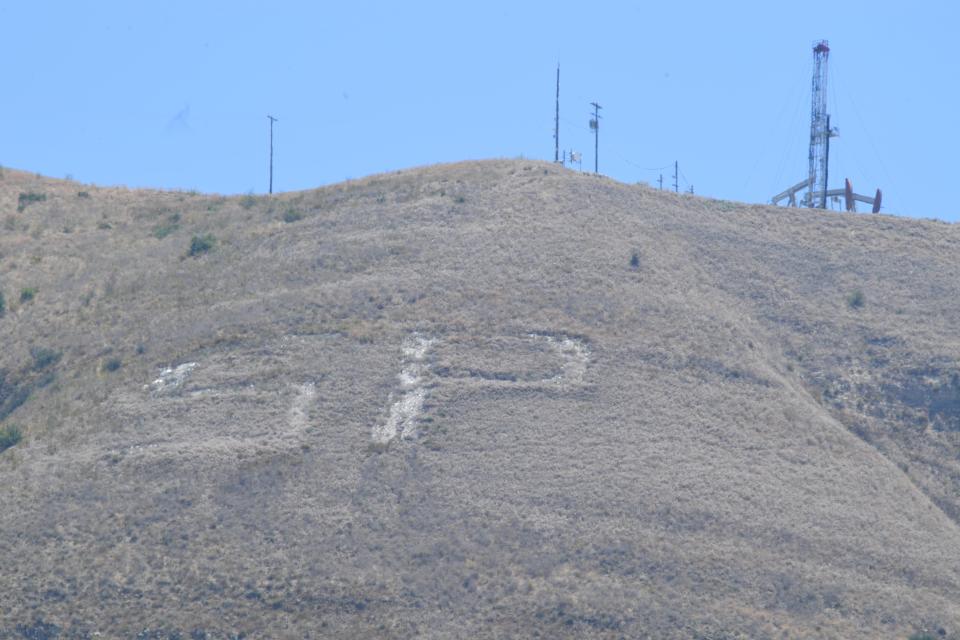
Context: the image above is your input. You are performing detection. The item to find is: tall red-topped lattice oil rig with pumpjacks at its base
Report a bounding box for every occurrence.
[772,40,883,213]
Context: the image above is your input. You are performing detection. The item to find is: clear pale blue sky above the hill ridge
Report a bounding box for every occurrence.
[0,0,960,220]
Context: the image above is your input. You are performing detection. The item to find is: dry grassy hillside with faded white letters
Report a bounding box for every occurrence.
[0,161,960,640]
